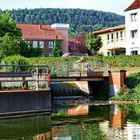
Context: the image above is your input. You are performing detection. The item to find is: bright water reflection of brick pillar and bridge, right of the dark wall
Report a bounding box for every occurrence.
[52,100,140,140]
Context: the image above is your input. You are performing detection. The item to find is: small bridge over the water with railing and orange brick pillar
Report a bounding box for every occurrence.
[50,63,126,96]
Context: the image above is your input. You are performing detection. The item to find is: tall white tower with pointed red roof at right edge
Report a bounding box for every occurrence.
[125,0,140,55]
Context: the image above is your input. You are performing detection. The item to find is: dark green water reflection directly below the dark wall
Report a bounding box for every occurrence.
[0,115,51,140]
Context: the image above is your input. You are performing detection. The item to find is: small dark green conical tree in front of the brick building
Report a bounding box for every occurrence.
[52,37,62,57]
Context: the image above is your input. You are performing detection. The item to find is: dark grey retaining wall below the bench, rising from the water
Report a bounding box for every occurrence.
[0,90,51,116]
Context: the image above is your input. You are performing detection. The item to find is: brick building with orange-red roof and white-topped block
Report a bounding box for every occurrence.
[16,23,69,56]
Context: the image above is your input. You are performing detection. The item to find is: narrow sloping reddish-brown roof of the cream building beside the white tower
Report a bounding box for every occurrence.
[94,25,125,35]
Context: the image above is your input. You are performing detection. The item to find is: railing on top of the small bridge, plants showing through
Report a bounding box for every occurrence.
[49,61,110,77]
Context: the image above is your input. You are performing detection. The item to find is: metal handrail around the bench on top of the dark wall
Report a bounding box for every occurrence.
[0,64,50,90]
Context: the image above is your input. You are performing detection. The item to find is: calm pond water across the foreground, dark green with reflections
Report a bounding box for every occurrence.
[0,99,140,140]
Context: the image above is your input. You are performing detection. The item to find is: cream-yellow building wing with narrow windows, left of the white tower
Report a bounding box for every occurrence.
[94,25,126,56]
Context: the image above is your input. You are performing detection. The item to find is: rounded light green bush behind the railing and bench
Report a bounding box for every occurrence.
[1,55,29,72]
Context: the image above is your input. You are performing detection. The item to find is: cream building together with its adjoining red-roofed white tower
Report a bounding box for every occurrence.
[94,0,140,55]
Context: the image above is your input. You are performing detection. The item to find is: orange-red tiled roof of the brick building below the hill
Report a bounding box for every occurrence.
[16,24,64,40]
